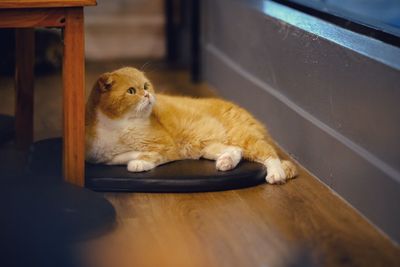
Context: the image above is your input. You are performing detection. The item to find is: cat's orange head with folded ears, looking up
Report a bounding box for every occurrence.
[92,67,156,119]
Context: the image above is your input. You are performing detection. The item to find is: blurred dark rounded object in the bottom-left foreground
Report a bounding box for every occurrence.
[0,176,116,266]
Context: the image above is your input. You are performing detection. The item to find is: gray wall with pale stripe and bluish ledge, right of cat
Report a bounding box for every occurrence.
[202,0,400,245]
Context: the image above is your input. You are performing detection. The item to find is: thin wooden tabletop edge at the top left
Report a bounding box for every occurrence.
[0,0,97,9]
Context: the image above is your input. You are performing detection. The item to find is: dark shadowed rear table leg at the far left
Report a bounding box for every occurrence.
[15,28,35,149]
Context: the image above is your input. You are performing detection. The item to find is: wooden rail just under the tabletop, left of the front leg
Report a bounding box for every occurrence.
[0,8,65,28]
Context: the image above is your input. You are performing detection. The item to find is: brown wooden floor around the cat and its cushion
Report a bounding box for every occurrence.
[0,63,400,267]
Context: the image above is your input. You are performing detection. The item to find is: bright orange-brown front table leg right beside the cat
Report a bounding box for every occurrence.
[63,7,85,186]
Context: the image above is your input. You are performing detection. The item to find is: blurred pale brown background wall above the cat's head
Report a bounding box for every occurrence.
[85,0,165,61]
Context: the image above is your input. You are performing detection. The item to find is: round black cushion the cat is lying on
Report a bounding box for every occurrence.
[29,139,266,192]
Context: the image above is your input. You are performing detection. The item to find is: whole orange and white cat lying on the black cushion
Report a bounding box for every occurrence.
[86,67,296,184]
